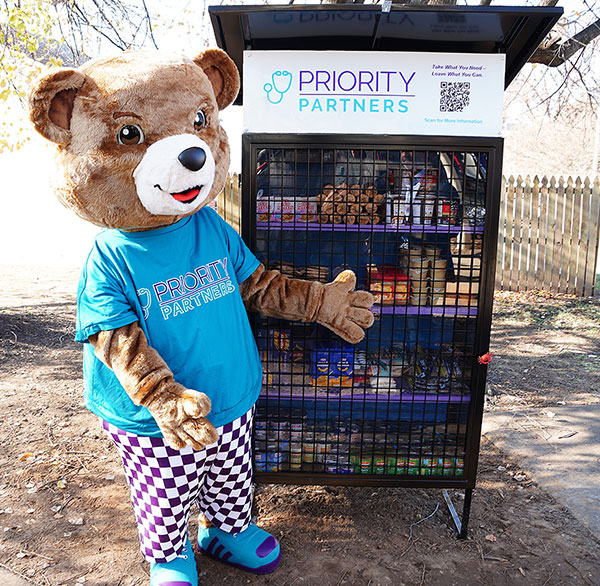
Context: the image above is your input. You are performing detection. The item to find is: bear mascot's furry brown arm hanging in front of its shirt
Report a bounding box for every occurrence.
[89,322,218,450]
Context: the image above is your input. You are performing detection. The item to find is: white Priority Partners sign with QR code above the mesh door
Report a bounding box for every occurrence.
[244,51,505,136]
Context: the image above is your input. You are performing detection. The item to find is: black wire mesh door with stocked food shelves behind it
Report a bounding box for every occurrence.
[245,137,496,486]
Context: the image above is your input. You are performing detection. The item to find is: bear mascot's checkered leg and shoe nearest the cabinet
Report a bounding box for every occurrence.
[198,409,281,574]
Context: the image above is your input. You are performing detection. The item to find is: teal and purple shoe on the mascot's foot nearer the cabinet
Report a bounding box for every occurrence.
[198,523,281,574]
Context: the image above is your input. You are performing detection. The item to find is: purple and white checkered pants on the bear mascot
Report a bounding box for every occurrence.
[103,409,253,563]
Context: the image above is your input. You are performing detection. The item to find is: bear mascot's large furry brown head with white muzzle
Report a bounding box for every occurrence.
[29,49,240,230]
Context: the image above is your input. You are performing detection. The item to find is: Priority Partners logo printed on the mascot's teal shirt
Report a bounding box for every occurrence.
[137,258,236,320]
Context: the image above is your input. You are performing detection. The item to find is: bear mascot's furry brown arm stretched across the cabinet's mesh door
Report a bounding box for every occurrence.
[240,264,374,344]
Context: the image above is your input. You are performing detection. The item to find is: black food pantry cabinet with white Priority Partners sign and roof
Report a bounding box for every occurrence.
[211,6,560,537]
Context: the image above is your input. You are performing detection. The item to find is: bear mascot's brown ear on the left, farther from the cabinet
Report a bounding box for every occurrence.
[29,68,85,145]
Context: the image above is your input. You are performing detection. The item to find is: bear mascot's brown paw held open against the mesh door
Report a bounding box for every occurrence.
[317,271,375,344]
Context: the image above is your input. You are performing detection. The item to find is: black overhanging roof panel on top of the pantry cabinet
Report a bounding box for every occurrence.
[209,4,563,104]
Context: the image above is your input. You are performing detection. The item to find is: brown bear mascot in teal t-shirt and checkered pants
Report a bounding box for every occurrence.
[29,49,373,586]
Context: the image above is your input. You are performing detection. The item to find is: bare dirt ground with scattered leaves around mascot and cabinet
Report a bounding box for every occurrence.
[0,267,600,586]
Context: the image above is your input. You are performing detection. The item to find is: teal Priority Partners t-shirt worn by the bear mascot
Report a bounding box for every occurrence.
[75,208,262,436]
